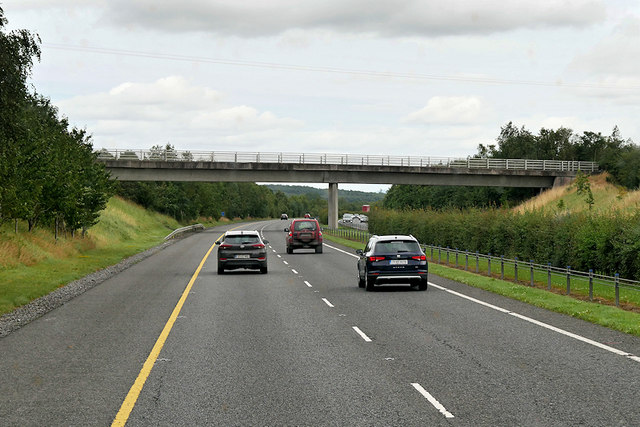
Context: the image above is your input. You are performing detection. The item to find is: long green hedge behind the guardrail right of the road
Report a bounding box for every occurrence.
[369,209,640,280]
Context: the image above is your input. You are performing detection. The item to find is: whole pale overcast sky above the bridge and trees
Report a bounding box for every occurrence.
[0,0,640,188]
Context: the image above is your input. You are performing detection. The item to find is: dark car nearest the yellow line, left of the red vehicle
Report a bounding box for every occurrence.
[218,230,269,274]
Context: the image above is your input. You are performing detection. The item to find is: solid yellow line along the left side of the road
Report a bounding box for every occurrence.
[111,232,229,427]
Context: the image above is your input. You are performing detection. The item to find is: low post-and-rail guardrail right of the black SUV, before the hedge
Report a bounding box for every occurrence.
[424,245,640,307]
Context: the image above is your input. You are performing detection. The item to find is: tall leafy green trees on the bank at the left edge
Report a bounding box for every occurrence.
[0,7,113,237]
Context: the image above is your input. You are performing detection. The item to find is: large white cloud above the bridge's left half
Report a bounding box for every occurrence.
[58,76,302,148]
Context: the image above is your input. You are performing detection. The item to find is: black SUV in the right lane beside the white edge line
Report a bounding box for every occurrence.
[356,235,429,291]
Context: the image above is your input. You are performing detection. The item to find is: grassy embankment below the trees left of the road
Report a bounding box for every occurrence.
[0,197,188,314]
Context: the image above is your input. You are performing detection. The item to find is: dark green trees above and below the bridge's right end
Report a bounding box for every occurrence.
[382,122,640,209]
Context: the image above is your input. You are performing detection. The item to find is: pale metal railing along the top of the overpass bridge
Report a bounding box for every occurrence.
[97,148,598,172]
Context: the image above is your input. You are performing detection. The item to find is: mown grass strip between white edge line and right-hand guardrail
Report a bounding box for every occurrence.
[324,234,640,336]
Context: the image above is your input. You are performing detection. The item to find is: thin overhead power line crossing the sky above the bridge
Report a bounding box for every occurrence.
[42,43,640,90]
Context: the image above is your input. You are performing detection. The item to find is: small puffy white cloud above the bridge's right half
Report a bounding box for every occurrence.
[404,96,488,124]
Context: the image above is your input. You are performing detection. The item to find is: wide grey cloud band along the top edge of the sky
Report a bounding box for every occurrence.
[101,0,605,37]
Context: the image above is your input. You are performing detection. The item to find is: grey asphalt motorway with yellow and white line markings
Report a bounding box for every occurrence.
[0,220,640,426]
